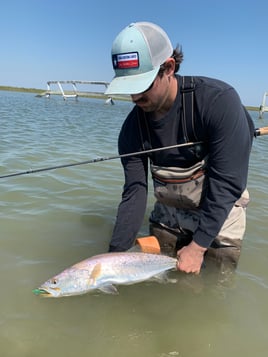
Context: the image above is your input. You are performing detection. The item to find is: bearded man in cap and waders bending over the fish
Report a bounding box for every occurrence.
[106,22,254,273]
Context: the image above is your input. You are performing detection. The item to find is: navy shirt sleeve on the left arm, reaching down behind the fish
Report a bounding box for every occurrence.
[109,111,148,251]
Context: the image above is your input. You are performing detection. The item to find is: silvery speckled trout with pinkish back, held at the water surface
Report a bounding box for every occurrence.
[33,252,177,297]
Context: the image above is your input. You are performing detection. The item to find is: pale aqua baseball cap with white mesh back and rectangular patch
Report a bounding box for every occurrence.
[105,22,173,94]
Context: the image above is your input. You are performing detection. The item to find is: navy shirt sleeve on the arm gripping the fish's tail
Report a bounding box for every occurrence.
[193,88,253,248]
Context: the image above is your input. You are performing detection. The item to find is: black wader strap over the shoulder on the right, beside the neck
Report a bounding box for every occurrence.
[180,76,198,142]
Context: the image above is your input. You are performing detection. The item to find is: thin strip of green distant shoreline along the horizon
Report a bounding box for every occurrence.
[0,86,260,111]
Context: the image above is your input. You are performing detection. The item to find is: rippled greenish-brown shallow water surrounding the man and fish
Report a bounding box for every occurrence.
[0,92,268,357]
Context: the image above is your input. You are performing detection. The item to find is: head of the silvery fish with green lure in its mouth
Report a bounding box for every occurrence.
[33,268,91,298]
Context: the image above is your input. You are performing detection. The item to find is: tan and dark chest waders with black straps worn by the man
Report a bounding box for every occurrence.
[139,76,249,266]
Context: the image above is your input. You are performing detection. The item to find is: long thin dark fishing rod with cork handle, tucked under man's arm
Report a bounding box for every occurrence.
[0,126,268,179]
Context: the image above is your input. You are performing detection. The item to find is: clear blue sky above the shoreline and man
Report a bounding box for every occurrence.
[0,0,268,106]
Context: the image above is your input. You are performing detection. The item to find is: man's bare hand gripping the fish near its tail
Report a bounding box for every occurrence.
[177,242,207,274]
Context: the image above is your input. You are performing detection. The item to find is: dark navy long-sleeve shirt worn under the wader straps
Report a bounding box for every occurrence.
[110,76,254,251]
